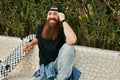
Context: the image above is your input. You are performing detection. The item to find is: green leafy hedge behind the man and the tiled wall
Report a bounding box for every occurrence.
[0,0,120,51]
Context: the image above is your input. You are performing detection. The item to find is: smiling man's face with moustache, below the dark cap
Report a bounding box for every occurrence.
[47,11,59,24]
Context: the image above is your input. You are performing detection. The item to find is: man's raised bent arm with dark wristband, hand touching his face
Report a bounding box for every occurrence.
[58,13,77,44]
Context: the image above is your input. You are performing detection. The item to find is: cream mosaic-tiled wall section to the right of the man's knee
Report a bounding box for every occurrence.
[75,46,120,80]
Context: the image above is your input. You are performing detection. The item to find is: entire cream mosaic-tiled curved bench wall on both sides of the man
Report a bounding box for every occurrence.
[0,36,120,80]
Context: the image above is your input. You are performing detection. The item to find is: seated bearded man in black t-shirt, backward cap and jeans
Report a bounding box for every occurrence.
[23,4,77,80]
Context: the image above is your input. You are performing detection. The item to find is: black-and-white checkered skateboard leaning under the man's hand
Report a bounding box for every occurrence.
[0,34,36,80]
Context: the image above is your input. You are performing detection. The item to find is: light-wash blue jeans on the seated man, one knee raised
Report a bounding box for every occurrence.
[30,43,76,80]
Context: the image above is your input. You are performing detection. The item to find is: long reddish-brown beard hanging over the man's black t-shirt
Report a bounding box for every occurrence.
[42,18,61,40]
